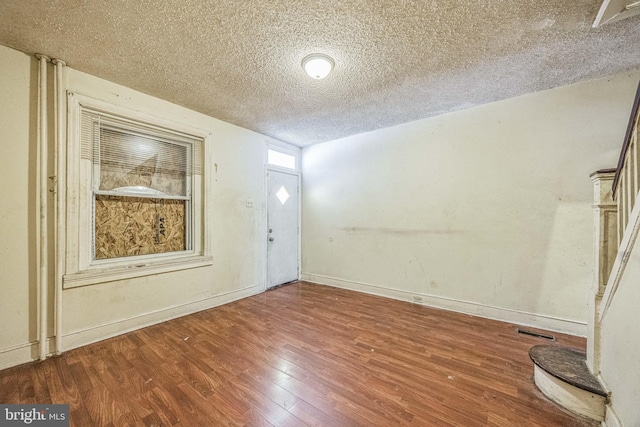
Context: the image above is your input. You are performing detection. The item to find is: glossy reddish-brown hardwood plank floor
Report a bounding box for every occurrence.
[0,282,597,427]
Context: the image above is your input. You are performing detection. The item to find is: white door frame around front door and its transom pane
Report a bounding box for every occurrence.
[262,143,302,292]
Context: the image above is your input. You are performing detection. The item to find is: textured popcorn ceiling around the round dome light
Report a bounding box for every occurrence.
[0,0,640,146]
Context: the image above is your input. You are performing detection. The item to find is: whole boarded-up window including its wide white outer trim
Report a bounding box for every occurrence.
[64,94,211,287]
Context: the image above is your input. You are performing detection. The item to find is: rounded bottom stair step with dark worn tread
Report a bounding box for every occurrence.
[529,345,608,421]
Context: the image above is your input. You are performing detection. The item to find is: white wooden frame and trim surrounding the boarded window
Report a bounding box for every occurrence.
[63,92,213,289]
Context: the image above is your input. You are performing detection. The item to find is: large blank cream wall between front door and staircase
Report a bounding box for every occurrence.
[302,72,640,335]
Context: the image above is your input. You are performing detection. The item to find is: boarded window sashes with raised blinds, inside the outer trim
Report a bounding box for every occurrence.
[82,110,201,260]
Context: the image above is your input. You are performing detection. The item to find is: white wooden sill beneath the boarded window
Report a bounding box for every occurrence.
[62,255,213,289]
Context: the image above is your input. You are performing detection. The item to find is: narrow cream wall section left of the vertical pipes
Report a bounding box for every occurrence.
[0,46,37,368]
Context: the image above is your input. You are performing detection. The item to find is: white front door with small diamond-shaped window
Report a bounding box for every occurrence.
[267,170,300,288]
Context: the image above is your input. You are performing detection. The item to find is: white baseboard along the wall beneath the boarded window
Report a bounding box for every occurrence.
[0,284,264,370]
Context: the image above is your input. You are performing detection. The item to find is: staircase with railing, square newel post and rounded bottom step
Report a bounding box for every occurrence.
[529,84,640,426]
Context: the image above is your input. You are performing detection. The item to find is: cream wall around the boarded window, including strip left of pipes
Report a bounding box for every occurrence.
[0,46,300,369]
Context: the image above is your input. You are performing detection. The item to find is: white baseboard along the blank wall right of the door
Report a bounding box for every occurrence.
[300,273,587,337]
